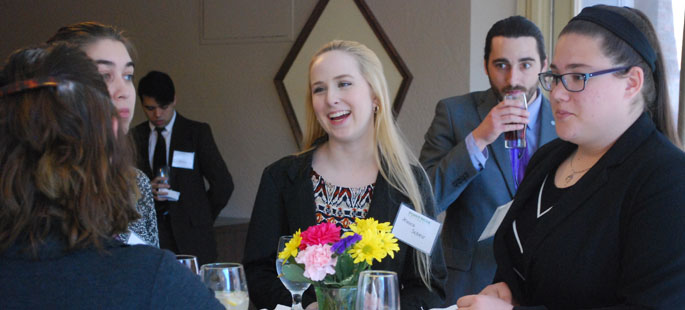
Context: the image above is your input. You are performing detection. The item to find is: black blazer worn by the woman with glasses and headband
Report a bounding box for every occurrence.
[494,114,685,309]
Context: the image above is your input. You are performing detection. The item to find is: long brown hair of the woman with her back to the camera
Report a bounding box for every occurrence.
[0,44,138,252]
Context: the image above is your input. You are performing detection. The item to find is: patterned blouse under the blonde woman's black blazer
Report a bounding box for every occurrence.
[312,170,376,231]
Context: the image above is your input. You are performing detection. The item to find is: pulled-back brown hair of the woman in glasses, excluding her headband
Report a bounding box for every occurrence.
[559,5,682,147]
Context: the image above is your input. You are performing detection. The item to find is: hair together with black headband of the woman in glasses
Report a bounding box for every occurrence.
[559,5,680,146]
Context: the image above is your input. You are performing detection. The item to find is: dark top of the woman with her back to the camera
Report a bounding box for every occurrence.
[0,237,224,310]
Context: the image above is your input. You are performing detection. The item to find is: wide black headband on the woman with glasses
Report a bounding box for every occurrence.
[571,6,656,72]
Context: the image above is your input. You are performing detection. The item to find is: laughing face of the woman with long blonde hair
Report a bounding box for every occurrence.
[309,51,376,147]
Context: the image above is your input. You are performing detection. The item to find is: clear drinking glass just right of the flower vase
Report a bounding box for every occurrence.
[356,270,400,310]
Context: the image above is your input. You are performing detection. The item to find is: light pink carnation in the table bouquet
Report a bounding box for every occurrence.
[295,244,338,281]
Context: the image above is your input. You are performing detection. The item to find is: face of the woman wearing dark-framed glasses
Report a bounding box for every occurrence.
[549,33,642,146]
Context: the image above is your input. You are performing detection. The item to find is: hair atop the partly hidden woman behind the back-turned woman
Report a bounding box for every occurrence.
[48,22,136,59]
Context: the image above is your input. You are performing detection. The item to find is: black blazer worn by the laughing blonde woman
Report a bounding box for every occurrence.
[243,151,447,309]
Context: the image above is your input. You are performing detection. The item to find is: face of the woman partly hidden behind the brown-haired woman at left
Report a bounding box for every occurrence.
[84,39,136,132]
